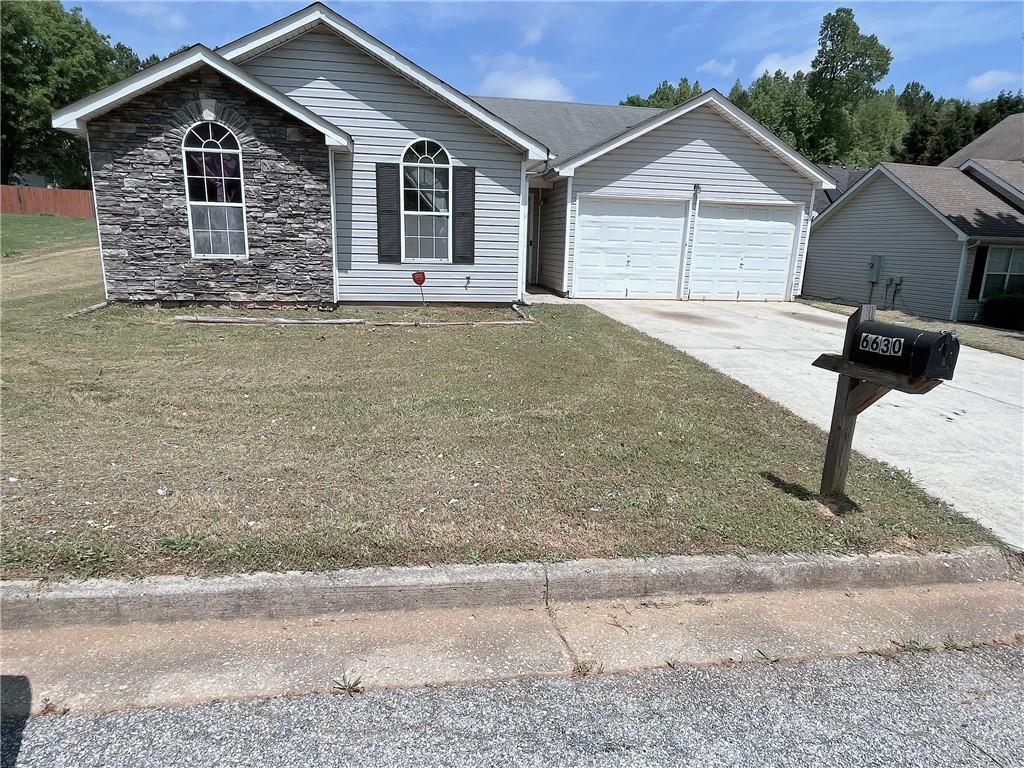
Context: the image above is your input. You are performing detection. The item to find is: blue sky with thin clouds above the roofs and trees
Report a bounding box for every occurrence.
[75,0,1024,103]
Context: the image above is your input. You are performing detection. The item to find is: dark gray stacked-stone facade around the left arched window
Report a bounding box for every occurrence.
[88,68,334,302]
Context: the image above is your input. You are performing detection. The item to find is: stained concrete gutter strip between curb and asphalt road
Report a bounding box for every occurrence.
[0,582,1024,713]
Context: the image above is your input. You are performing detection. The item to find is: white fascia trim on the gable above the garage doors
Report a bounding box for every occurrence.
[554,90,836,189]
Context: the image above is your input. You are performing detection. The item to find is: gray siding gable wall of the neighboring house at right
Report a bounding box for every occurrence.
[803,173,971,318]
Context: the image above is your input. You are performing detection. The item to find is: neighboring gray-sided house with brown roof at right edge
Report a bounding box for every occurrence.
[803,125,1024,321]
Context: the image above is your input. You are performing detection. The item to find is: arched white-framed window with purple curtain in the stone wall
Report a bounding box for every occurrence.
[183,123,247,259]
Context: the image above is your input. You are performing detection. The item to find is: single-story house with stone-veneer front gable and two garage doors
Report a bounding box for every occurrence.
[53,3,834,303]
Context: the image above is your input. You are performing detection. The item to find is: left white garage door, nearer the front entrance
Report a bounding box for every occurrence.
[573,198,686,299]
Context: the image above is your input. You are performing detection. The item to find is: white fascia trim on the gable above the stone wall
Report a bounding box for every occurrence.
[53,45,352,151]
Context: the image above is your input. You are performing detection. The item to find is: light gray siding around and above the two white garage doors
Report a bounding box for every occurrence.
[568,106,814,296]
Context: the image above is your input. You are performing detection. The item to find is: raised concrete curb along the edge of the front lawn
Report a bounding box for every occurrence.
[0,547,1018,630]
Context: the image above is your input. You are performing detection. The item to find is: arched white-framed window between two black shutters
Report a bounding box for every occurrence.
[401,138,452,262]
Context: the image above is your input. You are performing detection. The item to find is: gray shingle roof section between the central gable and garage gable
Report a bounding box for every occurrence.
[473,96,663,158]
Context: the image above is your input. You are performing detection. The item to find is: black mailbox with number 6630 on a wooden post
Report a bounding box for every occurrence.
[850,321,959,380]
